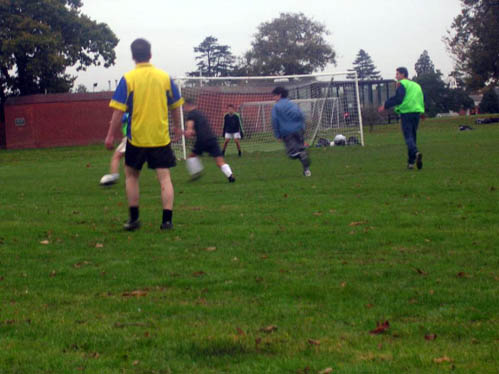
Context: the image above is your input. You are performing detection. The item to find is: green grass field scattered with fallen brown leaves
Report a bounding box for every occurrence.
[0,119,499,374]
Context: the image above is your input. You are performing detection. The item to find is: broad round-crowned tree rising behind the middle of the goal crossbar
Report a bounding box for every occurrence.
[239,13,336,75]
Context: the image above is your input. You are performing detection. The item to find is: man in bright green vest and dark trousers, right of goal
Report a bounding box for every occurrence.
[378,67,424,169]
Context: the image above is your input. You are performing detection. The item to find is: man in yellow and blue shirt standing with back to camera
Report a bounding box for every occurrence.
[105,39,183,231]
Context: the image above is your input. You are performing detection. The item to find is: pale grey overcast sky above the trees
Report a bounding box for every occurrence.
[72,0,461,90]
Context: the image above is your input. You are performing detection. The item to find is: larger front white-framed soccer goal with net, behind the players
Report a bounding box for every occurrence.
[174,72,364,158]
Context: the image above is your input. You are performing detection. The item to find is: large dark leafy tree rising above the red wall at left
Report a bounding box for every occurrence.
[0,0,118,118]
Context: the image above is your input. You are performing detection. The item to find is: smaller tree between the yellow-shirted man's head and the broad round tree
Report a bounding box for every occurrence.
[187,36,235,77]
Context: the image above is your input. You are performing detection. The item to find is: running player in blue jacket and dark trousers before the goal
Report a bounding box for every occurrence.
[272,87,312,177]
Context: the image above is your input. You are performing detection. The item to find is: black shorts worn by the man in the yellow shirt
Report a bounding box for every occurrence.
[125,141,177,170]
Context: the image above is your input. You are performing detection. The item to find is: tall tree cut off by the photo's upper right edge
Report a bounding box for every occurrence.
[444,0,499,89]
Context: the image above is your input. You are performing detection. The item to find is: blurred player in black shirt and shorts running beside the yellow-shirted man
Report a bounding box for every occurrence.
[184,98,236,183]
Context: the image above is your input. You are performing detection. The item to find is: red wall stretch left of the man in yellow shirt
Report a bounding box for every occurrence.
[5,92,112,149]
